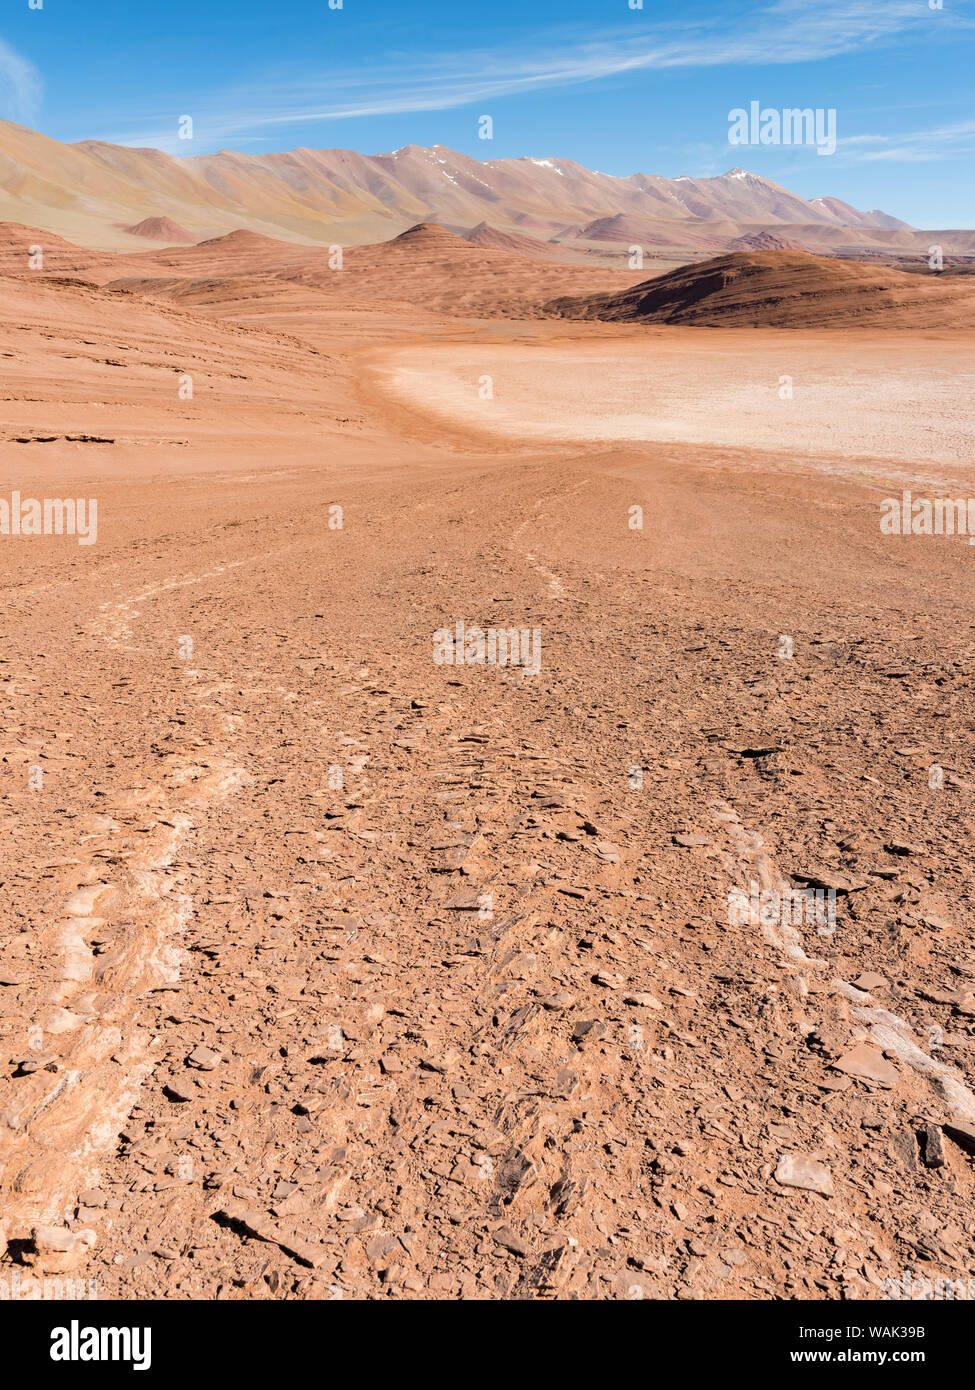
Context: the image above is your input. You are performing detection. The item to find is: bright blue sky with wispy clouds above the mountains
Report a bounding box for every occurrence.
[0,0,975,227]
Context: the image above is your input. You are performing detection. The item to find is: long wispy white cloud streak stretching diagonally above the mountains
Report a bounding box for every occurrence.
[102,0,945,154]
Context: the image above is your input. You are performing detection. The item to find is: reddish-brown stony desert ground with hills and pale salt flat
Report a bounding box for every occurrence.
[0,227,975,1300]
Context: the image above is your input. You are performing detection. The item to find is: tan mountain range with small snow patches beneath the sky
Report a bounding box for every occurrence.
[0,121,975,259]
